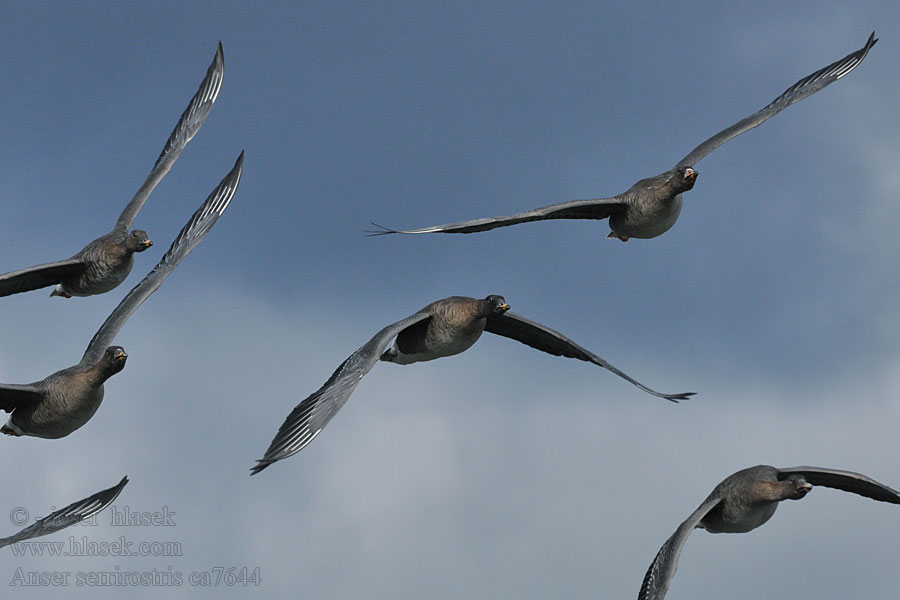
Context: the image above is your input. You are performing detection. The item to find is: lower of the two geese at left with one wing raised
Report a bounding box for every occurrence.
[0,152,244,438]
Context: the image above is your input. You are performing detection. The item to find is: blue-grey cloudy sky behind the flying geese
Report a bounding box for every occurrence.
[0,2,900,600]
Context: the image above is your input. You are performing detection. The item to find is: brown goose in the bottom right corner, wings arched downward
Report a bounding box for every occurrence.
[638,465,900,600]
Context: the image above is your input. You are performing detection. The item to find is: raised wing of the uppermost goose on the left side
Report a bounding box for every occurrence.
[115,42,225,231]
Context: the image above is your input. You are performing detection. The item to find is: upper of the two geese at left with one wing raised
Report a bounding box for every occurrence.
[0,42,225,298]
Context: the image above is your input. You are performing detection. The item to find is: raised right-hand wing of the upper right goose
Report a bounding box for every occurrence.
[675,31,878,169]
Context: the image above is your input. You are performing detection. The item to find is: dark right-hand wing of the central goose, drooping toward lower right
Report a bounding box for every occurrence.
[484,312,694,402]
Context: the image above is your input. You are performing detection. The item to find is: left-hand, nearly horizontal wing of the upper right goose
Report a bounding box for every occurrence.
[367,197,625,236]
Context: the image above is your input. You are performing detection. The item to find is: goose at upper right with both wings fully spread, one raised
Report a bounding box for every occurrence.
[368,32,878,242]
